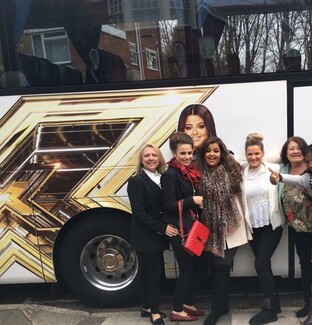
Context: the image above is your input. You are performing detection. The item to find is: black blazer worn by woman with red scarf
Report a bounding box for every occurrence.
[160,166,197,230]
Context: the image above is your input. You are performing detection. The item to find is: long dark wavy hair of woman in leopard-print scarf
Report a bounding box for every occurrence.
[196,137,243,194]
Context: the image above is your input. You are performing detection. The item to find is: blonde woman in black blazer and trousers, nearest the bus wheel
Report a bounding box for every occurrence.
[128,144,177,325]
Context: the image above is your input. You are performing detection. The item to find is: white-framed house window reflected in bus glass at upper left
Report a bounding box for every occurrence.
[32,28,71,64]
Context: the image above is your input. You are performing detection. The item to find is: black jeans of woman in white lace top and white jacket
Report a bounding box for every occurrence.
[249,225,283,298]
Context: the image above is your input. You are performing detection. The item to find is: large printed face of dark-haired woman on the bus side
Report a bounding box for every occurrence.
[183,115,209,148]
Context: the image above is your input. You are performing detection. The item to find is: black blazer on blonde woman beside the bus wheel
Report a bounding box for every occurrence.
[127,171,168,253]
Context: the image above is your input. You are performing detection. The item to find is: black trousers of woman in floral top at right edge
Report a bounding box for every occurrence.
[289,227,312,301]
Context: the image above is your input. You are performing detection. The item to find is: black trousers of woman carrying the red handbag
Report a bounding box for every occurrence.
[169,236,204,312]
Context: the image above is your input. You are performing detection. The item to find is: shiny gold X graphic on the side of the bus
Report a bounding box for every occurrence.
[0,87,216,304]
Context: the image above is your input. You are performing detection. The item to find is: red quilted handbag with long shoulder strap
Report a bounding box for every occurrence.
[178,200,210,256]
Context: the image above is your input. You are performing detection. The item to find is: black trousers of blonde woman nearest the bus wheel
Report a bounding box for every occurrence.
[137,252,164,314]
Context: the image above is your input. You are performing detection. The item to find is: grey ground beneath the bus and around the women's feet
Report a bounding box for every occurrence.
[0,281,305,325]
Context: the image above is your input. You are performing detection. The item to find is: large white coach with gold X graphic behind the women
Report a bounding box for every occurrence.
[0,0,312,306]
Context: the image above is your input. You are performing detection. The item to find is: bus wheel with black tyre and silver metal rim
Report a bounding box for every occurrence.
[60,214,140,307]
